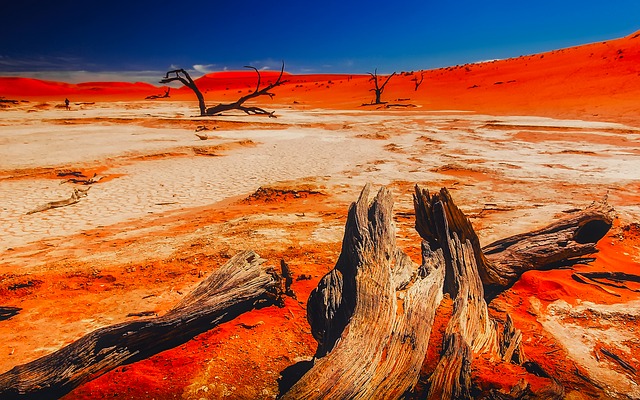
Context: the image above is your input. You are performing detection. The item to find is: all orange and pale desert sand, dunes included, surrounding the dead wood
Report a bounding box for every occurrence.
[0,34,640,399]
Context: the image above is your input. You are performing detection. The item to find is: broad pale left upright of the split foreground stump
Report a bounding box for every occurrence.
[283,185,444,399]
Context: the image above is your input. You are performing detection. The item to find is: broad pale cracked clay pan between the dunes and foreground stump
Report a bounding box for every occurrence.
[0,103,640,251]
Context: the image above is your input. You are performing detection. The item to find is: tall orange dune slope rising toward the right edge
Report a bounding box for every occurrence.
[400,32,640,120]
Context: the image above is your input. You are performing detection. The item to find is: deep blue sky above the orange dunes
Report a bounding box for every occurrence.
[0,0,640,81]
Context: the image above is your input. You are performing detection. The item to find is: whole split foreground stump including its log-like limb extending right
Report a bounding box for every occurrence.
[283,186,611,399]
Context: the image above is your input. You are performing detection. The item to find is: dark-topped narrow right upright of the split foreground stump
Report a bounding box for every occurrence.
[413,186,498,399]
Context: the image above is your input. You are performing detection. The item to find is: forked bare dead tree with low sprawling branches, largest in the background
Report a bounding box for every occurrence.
[160,62,287,118]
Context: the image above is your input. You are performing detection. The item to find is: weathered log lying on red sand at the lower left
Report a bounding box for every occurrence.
[0,251,282,399]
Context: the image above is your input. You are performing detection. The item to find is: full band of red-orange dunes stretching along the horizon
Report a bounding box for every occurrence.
[0,32,640,124]
